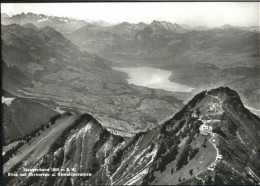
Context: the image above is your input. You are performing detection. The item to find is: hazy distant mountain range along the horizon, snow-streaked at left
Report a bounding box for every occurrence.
[1,13,259,34]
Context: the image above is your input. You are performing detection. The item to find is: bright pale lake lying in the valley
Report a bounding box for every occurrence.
[113,67,193,92]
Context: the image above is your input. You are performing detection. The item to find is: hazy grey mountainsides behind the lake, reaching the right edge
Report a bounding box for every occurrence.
[68,21,259,63]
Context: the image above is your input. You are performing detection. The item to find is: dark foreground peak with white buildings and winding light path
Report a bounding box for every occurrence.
[143,88,260,184]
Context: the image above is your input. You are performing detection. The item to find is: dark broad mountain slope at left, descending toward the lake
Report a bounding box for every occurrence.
[2,24,110,92]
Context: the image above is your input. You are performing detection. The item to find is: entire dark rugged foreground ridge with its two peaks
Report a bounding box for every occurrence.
[4,87,260,185]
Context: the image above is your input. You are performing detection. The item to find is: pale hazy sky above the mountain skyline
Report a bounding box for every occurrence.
[1,2,260,27]
